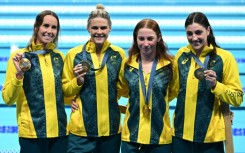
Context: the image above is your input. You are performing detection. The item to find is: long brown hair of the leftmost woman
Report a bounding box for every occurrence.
[26,10,60,48]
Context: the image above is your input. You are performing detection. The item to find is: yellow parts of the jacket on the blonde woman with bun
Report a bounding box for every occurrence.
[62,41,125,137]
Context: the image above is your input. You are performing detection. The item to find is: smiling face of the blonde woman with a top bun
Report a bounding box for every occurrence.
[88,17,111,47]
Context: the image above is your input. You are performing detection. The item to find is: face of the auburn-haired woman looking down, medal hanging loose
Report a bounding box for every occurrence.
[137,28,160,57]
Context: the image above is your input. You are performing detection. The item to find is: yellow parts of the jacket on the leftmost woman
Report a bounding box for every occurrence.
[2,42,68,138]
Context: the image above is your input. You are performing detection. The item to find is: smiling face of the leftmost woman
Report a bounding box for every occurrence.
[35,15,58,45]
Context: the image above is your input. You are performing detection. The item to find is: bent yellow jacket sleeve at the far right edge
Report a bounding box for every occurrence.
[212,53,244,106]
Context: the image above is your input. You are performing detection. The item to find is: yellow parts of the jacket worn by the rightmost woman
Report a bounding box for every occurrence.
[173,45,243,143]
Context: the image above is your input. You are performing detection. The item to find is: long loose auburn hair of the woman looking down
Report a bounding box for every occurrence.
[126,19,173,64]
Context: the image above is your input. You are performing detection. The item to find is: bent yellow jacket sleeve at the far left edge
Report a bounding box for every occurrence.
[2,51,23,105]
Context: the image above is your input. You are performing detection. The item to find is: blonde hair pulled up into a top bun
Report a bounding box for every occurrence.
[87,4,111,28]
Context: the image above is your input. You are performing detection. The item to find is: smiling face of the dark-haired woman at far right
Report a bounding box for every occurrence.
[186,23,210,54]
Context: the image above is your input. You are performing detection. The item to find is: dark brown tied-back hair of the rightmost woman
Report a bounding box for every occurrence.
[185,12,219,53]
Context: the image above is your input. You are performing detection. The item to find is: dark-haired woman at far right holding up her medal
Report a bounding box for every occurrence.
[172,12,243,153]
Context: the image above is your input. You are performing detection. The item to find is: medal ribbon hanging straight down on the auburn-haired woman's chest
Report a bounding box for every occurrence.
[139,58,157,105]
